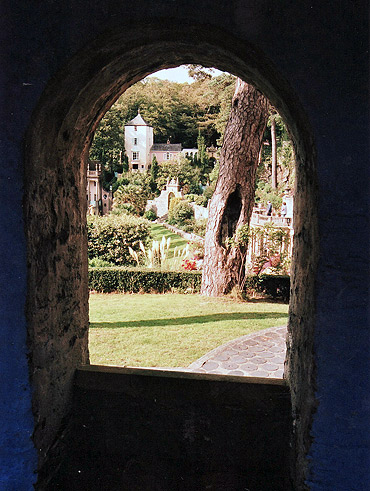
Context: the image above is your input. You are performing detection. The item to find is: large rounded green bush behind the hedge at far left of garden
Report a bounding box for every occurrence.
[87,215,150,266]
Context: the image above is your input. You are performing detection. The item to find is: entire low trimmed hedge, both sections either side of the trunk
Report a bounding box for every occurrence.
[89,267,290,302]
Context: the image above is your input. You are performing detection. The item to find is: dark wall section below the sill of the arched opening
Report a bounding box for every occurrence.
[40,366,292,491]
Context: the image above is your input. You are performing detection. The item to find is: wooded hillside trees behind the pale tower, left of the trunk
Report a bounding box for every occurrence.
[90,73,235,189]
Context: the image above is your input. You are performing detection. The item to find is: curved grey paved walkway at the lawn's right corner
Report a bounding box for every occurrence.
[188,326,287,378]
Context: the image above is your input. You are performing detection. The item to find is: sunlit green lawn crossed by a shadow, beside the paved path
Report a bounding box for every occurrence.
[89,293,288,367]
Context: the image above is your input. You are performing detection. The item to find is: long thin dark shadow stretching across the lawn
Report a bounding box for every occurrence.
[90,312,287,329]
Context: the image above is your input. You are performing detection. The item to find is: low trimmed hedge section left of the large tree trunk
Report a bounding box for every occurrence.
[89,267,202,293]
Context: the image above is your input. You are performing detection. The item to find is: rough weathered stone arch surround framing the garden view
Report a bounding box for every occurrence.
[24,20,317,484]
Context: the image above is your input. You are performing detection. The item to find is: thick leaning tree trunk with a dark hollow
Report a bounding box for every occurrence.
[201,79,269,296]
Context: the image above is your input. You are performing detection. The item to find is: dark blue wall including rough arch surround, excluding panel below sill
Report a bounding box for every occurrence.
[0,0,370,490]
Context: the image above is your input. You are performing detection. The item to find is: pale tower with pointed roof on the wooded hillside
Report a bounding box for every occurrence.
[125,111,153,172]
